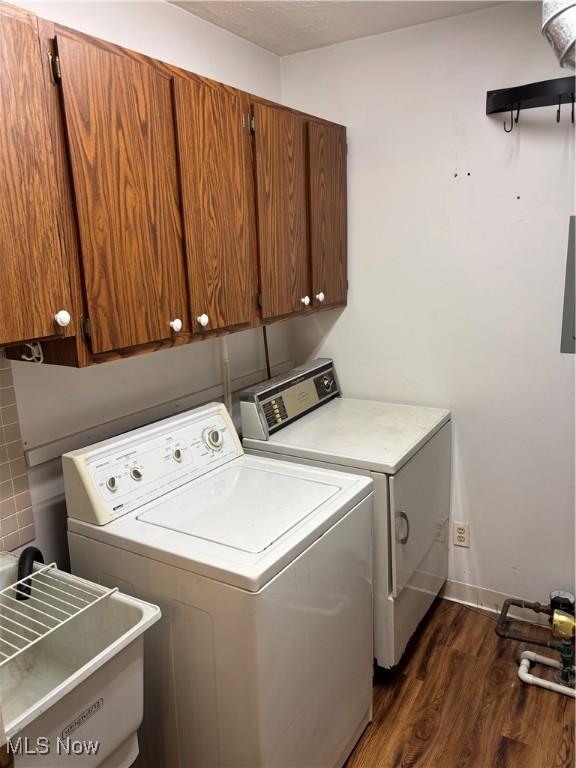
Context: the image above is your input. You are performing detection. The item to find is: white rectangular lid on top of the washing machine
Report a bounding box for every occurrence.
[137,464,341,554]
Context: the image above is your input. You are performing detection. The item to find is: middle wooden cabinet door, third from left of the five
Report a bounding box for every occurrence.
[174,78,256,330]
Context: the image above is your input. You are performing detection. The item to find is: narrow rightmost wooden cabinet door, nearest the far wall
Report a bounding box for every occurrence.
[308,122,348,306]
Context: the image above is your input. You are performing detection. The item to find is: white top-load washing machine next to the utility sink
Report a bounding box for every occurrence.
[63,404,373,767]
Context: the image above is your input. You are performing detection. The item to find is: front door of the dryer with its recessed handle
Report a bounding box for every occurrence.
[390,423,450,597]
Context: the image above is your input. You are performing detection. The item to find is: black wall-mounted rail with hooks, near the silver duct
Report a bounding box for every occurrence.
[486,75,576,127]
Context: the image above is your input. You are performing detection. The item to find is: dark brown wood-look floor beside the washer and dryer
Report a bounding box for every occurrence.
[346,600,574,768]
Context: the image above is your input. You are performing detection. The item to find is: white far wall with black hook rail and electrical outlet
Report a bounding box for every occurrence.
[282,3,574,600]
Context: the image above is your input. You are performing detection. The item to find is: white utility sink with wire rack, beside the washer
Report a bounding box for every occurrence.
[0,553,160,768]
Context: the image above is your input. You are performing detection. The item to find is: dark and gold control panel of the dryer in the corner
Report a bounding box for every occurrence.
[240,358,340,440]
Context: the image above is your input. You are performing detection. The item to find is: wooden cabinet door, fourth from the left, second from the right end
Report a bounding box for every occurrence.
[253,104,310,318]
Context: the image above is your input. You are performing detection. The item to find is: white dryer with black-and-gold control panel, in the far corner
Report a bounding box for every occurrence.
[240,359,451,667]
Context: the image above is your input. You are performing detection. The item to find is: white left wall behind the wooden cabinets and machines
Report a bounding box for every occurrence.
[13,2,290,563]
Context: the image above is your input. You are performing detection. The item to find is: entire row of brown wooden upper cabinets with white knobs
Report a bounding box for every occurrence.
[0,6,347,365]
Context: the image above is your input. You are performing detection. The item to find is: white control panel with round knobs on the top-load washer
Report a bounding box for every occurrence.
[62,403,243,525]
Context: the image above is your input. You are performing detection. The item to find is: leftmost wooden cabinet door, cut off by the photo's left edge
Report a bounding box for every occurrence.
[0,10,70,346]
